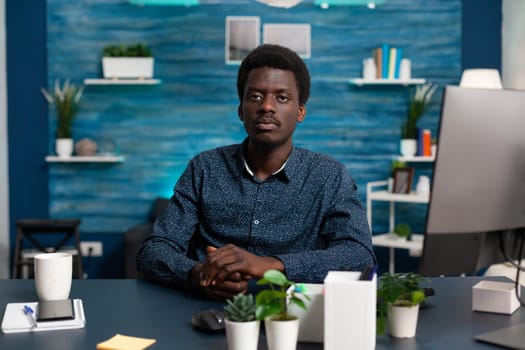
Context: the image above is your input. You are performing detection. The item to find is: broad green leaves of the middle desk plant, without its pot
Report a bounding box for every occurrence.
[255,270,310,321]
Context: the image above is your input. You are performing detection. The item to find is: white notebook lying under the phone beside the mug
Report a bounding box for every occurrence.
[2,299,86,333]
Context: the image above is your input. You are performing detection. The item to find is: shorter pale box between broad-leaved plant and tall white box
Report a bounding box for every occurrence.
[291,283,324,343]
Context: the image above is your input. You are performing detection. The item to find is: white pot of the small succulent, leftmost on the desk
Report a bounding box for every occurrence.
[225,319,261,350]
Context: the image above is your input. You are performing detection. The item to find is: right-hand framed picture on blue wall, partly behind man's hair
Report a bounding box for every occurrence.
[263,23,311,58]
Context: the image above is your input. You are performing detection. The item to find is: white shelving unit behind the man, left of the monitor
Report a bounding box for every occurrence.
[366,180,429,273]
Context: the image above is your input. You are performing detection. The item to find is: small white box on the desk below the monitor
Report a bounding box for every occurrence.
[472,281,521,315]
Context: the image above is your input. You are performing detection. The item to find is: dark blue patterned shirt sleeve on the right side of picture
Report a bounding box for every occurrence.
[276,166,376,283]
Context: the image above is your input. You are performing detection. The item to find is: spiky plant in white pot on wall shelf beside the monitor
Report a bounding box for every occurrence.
[400,84,437,157]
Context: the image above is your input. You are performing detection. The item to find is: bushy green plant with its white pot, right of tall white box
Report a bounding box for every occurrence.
[377,272,428,338]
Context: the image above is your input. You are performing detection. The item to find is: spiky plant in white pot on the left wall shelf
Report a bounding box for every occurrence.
[41,79,84,158]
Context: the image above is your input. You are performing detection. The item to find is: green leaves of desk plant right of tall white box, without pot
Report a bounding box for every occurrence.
[376,272,428,335]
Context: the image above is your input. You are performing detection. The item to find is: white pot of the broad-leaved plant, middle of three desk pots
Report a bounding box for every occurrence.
[264,318,299,350]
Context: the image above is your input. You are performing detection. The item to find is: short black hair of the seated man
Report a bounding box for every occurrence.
[237,44,310,105]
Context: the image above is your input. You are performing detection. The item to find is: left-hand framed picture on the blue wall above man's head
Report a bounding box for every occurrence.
[224,16,261,64]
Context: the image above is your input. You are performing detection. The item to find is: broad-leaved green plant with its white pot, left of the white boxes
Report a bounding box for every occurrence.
[256,270,310,350]
